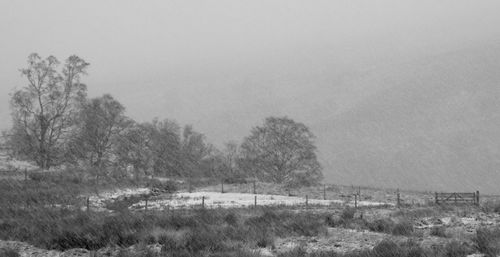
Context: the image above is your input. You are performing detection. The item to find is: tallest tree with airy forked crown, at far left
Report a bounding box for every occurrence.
[9,53,89,169]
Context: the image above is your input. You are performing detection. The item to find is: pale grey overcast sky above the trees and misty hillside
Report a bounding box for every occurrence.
[0,0,500,190]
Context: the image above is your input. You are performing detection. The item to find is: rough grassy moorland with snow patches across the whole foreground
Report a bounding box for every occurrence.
[0,167,500,257]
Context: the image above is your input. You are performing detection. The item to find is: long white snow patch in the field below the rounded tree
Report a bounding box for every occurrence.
[130,192,391,210]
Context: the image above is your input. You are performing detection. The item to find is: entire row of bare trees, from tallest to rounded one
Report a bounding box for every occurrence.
[4,54,322,185]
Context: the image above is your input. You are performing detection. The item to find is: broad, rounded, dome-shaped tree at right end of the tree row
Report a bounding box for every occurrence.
[241,117,323,184]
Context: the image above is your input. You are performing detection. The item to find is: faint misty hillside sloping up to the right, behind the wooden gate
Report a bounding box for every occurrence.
[314,43,500,193]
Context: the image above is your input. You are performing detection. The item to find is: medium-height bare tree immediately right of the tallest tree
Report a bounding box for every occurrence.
[71,94,130,170]
